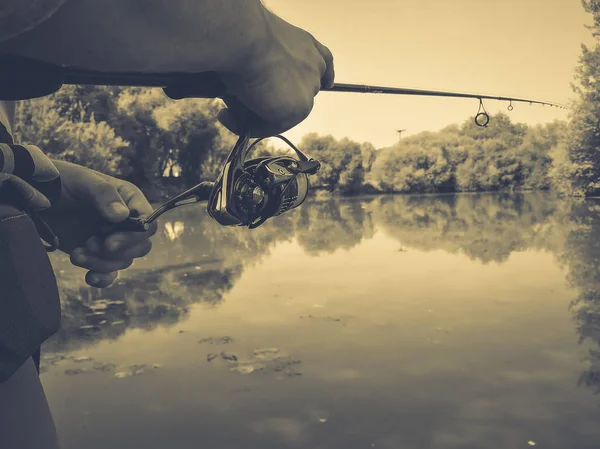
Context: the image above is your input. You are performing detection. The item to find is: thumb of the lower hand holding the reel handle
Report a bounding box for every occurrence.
[78,174,129,223]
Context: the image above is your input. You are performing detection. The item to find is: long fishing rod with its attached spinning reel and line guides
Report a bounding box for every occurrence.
[0,54,567,248]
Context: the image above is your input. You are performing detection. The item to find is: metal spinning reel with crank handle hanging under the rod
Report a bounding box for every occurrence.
[106,124,321,234]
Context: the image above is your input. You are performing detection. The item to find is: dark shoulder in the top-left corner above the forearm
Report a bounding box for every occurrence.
[0,0,68,42]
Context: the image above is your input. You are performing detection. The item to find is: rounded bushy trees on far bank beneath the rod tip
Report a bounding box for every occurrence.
[369,114,566,193]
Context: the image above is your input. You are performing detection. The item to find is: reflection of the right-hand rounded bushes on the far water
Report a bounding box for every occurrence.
[373,193,558,263]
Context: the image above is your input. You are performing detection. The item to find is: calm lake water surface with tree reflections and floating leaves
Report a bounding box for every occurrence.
[42,194,600,449]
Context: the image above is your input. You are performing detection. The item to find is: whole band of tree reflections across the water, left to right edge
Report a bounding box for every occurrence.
[44,193,600,392]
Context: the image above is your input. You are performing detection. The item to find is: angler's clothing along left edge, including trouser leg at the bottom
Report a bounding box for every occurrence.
[0,102,61,449]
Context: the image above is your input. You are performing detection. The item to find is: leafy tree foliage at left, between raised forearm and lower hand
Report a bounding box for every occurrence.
[16,86,230,199]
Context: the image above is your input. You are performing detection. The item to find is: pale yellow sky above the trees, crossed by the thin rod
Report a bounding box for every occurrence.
[264,0,594,148]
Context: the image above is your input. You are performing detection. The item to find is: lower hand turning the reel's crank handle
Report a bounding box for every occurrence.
[39,161,157,288]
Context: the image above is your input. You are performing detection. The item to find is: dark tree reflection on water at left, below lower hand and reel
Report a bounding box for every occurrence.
[44,208,293,352]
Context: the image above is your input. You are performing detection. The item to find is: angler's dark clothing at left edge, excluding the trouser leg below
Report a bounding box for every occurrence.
[0,102,60,382]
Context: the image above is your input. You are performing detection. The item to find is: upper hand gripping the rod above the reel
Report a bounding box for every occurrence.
[219,11,335,137]
